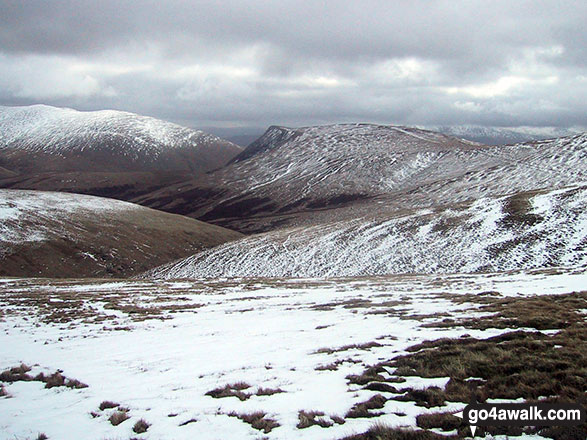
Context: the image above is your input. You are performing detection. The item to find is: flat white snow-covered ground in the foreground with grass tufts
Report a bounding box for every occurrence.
[0,269,587,440]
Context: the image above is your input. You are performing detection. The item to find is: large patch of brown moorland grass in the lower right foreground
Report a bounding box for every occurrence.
[348,292,587,440]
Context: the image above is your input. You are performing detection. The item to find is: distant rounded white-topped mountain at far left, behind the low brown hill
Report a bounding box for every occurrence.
[0,105,242,200]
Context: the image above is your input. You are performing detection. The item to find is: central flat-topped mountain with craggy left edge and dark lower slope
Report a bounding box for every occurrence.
[136,124,487,231]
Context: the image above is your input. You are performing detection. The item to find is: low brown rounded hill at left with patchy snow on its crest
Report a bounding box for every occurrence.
[0,190,241,277]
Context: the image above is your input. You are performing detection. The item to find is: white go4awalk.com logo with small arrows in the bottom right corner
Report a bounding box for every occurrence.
[455,402,587,436]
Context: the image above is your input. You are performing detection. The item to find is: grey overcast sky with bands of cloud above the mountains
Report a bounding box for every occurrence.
[0,0,587,129]
